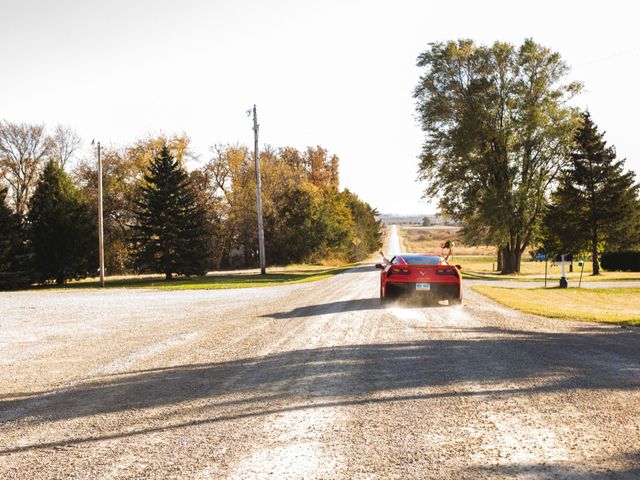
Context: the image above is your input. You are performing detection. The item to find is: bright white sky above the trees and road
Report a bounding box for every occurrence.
[0,0,640,213]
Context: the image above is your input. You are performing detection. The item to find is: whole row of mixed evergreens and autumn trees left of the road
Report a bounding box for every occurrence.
[0,122,381,288]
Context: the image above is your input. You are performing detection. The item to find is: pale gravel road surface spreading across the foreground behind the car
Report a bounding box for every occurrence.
[0,234,640,479]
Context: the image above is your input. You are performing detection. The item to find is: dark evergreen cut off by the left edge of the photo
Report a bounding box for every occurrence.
[0,187,32,290]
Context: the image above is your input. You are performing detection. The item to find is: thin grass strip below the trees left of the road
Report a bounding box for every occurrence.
[36,265,354,290]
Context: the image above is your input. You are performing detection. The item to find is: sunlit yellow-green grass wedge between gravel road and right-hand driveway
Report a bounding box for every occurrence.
[472,286,640,326]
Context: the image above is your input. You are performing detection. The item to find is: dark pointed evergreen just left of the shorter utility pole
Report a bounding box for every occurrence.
[28,160,98,285]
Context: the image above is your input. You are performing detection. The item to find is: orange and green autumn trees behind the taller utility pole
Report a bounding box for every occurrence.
[203,146,381,266]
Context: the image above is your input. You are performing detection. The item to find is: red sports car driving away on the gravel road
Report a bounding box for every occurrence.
[376,253,462,305]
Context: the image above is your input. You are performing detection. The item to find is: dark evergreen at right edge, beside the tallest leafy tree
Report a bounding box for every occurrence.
[546,112,640,275]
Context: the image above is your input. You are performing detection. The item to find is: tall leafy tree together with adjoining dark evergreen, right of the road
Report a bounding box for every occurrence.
[414,39,640,274]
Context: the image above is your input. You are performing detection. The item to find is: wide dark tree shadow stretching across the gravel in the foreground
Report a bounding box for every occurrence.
[0,322,640,454]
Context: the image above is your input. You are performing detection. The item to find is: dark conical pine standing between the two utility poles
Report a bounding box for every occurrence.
[132,145,206,280]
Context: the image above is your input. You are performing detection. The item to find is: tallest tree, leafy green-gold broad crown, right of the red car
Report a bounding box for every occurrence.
[415,40,580,273]
